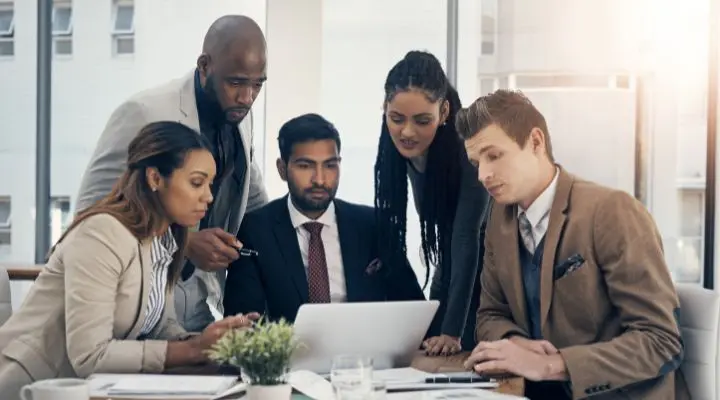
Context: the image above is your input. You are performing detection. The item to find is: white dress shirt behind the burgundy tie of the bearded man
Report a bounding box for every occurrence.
[288,196,347,303]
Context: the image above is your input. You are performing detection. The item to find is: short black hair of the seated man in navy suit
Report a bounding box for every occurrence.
[278,114,340,163]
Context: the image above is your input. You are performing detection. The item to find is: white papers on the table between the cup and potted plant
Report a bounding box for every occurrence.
[88,374,245,400]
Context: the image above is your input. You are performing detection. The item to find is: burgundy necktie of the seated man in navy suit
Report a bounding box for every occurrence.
[303,222,330,303]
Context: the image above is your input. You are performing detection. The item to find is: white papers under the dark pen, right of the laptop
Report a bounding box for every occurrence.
[373,367,498,391]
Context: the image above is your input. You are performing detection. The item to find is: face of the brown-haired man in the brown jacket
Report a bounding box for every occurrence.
[465,124,545,204]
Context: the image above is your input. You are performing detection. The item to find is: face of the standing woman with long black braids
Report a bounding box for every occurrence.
[385,89,448,159]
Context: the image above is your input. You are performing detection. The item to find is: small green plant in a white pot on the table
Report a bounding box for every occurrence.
[208,319,299,400]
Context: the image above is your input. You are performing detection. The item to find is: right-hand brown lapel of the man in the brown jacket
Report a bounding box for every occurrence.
[540,168,573,328]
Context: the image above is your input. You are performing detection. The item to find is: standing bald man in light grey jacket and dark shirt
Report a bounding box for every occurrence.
[76,15,267,332]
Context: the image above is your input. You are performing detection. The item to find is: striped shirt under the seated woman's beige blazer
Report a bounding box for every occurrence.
[140,228,178,336]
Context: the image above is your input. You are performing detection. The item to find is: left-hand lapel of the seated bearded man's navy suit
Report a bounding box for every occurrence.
[271,196,308,304]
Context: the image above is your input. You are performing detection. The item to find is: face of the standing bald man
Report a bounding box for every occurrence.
[199,43,267,124]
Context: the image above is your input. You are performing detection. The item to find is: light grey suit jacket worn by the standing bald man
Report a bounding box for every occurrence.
[75,70,267,332]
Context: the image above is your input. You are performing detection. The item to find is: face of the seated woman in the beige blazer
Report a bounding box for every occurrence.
[158,150,215,227]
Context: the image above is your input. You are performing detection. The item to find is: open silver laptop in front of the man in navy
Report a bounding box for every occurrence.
[290,300,440,374]
